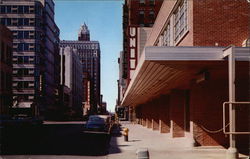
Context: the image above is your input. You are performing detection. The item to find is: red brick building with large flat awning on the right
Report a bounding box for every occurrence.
[121,0,250,155]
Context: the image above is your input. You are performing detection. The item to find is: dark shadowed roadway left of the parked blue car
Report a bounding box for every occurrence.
[1,122,110,159]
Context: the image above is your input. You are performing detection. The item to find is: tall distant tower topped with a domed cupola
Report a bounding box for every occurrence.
[60,24,101,113]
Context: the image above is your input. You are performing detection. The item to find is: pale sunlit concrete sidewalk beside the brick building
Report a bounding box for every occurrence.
[107,122,247,159]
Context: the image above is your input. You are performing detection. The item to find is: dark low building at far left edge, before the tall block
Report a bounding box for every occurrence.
[0,25,12,115]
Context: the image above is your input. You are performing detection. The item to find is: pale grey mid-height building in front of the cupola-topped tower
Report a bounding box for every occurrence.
[60,46,83,116]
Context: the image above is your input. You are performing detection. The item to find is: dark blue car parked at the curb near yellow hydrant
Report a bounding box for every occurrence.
[85,115,110,132]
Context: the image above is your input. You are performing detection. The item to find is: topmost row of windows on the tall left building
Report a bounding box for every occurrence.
[0,5,42,15]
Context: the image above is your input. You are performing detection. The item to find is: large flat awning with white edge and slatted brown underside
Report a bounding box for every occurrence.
[121,46,250,106]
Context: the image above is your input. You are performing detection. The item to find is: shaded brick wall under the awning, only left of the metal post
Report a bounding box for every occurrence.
[190,65,228,146]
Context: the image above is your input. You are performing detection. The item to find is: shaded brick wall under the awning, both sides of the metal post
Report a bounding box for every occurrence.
[190,62,249,148]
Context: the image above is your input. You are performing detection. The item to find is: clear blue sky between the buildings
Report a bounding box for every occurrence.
[55,0,123,112]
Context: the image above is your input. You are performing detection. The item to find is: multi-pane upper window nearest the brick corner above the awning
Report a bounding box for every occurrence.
[174,0,187,42]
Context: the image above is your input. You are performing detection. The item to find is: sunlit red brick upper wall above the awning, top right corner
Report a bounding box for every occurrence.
[193,0,250,46]
